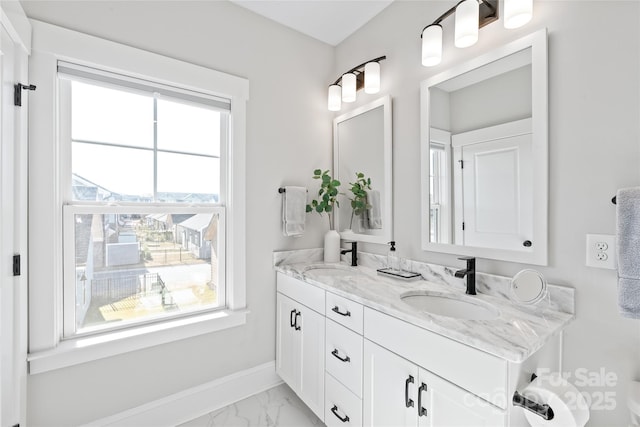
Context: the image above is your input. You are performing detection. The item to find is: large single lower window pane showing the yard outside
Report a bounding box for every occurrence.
[74,212,224,333]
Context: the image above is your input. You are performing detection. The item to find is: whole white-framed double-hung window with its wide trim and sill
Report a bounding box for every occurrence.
[28,21,249,374]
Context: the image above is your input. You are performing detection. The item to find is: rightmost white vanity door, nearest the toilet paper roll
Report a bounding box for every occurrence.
[416,369,506,427]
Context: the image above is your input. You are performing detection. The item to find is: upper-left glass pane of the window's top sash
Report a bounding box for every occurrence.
[71,81,153,148]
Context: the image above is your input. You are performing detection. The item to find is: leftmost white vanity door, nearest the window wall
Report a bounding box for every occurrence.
[276,292,301,393]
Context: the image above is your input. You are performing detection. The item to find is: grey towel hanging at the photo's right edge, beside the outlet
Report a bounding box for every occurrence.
[616,187,640,319]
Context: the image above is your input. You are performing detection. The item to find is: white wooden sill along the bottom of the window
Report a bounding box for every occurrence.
[27,310,249,375]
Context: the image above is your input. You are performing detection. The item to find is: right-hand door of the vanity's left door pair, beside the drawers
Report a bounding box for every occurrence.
[293,304,325,420]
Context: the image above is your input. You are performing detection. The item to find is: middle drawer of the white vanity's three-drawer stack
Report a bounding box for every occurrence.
[324,319,363,397]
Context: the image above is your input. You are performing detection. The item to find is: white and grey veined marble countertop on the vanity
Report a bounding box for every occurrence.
[275,261,574,363]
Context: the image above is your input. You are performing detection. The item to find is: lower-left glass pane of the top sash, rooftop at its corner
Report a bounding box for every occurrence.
[71,142,153,201]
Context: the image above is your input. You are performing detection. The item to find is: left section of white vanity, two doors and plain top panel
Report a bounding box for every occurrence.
[276,274,325,420]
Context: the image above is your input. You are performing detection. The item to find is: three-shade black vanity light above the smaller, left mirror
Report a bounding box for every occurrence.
[327,56,387,111]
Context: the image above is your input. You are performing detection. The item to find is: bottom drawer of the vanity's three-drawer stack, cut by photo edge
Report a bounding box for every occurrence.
[324,374,362,427]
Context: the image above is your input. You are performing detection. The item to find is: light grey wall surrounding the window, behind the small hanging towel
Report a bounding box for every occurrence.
[24,1,335,426]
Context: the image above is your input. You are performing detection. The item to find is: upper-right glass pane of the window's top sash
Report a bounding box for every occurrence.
[158,99,221,156]
